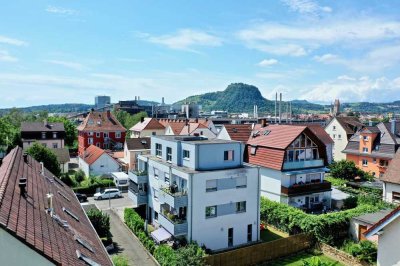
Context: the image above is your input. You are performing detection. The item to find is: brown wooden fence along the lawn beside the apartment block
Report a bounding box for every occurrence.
[205,233,314,266]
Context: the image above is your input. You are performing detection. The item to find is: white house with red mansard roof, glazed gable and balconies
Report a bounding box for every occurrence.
[245,124,331,211]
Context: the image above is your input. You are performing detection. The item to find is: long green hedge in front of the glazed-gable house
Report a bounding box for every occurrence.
[260,198,380,245]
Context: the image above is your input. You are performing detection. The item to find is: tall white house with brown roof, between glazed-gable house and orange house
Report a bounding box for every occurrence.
[325,116,364,161]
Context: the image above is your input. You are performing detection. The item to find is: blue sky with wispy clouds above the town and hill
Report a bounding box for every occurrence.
[0,0,400,108]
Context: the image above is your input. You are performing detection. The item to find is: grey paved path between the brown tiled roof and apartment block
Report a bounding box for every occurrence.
[104,210,157,266]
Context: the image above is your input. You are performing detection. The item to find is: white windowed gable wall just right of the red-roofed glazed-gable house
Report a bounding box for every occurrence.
[325,118,348,161]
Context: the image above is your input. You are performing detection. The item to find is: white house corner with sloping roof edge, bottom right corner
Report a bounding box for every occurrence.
[364,206,400,266]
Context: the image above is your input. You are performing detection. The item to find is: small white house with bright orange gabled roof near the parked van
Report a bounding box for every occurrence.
[78,145,121,177]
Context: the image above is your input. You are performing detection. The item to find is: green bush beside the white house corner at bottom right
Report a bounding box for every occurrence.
[342,240,378,263]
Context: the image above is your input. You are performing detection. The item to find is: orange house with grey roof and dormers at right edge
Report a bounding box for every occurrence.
[343,122,400,178]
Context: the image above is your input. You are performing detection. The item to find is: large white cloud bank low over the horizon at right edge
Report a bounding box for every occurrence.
[301,76,400,102]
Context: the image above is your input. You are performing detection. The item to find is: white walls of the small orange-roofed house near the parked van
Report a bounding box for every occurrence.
[79,153,121,176]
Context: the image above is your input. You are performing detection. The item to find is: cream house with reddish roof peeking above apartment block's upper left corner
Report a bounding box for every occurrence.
[129,117,165,138]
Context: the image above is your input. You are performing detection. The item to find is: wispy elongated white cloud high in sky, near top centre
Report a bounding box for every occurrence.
[141,29,222,51]
